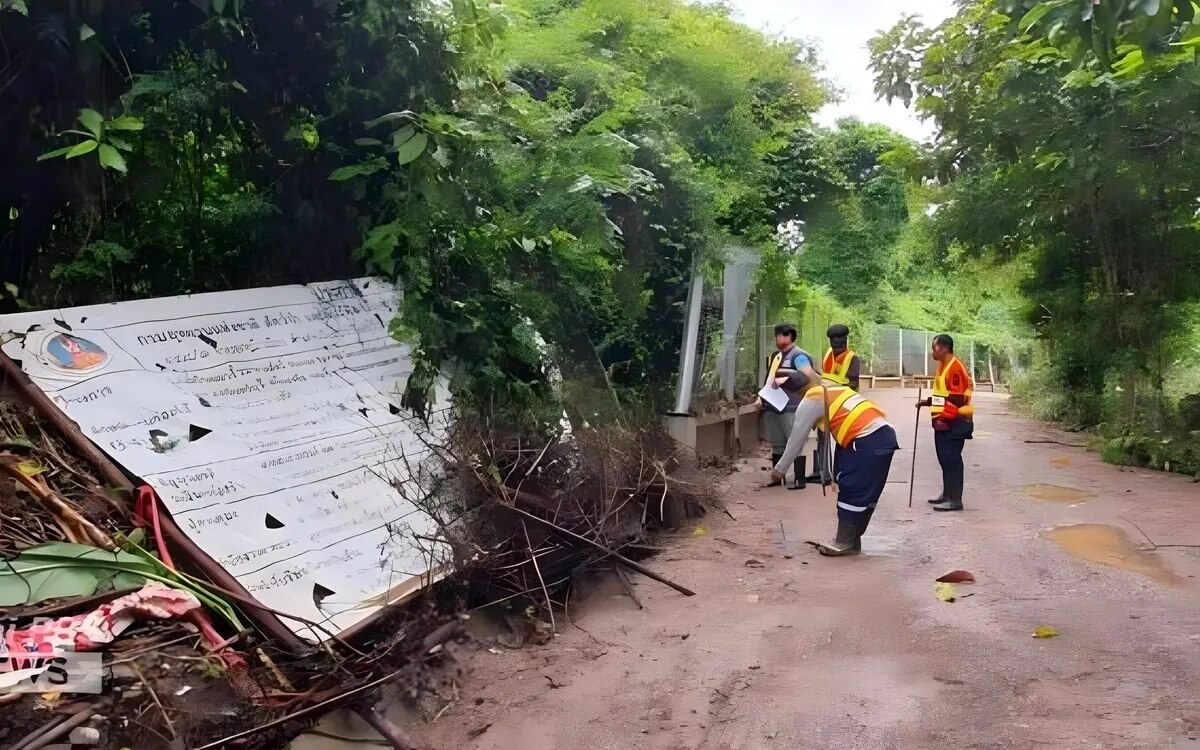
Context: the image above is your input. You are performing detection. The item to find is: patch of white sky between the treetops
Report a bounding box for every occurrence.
[731,0,954,140]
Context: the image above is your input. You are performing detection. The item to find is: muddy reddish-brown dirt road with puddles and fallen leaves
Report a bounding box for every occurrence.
[398,391,1200,750]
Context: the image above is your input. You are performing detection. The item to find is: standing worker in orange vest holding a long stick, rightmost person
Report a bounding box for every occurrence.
[917,334,974,511]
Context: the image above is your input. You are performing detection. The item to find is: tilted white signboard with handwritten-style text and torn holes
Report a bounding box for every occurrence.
[0,278,449,640]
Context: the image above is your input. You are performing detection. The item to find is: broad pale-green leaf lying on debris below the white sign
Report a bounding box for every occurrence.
[0,542,155,607]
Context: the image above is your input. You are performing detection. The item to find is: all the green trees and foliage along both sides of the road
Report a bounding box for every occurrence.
[0,0,1200,472]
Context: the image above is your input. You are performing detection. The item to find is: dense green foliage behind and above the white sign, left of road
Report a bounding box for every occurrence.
[0,0,827,422]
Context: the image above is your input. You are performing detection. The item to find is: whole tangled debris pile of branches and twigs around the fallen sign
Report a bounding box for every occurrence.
[0,362,714,750]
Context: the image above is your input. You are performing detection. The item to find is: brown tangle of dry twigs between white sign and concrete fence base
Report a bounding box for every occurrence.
[443,422,718,629]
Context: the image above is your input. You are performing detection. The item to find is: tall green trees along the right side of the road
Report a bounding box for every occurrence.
[871,0,1200,472]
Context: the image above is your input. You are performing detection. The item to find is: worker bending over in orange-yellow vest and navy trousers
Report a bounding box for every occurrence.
[770,377,900,557]
